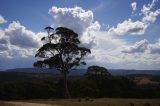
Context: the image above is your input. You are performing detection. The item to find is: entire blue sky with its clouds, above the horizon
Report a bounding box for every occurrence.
[0,0,160,70]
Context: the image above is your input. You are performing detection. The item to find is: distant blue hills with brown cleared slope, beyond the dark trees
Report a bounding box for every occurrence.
[0,68,160,85]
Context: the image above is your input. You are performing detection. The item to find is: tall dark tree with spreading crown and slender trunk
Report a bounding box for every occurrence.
[34,27,91,98]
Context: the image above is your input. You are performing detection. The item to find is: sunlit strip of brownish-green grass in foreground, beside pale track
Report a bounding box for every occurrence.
[0,98,160,106]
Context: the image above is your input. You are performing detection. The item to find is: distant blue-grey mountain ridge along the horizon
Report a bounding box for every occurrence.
[5,68,160,76]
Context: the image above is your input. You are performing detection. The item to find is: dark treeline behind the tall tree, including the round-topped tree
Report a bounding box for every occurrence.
[0,67,160,100]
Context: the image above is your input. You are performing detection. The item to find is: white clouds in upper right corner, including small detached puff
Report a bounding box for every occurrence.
[108,0,160,35]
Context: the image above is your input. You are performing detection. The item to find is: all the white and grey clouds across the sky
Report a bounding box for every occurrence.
[0,0,160,69]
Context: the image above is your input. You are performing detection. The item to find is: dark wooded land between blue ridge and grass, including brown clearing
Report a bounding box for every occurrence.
[0,66,160,100]
